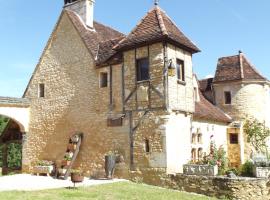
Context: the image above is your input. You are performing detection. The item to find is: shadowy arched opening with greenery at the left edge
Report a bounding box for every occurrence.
[0,115,24,175]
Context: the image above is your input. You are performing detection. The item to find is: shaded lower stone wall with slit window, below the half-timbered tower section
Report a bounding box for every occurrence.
[133,111,167,169]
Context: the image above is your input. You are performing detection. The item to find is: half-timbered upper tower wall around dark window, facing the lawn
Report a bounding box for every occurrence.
[124,43,165,110]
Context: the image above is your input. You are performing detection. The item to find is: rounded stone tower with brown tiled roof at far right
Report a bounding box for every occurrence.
[201,51,270,166]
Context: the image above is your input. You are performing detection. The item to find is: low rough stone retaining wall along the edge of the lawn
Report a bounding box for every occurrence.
[131,169,270,200]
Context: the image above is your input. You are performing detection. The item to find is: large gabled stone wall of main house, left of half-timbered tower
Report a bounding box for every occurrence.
[23,14,129,175]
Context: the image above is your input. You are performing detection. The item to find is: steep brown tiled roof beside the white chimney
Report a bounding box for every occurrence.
[65,10,124,61]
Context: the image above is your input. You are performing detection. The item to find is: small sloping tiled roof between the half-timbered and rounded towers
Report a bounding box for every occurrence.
[193,91,232,123]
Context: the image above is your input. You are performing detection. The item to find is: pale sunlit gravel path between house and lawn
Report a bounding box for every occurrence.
[0,174,126,191]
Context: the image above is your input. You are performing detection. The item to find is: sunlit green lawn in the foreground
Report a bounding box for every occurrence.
[0,180,216,200]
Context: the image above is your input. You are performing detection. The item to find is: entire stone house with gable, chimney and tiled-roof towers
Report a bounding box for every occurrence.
[0,0,270,178]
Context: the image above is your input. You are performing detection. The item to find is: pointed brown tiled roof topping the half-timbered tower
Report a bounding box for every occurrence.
[115,6,200,53]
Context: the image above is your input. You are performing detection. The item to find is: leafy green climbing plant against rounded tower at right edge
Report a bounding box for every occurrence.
[244,118,270,153]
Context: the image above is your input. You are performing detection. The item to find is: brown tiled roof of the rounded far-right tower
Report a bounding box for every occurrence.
[213,53,267,82]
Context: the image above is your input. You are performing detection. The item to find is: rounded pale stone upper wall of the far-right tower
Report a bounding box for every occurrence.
[214,82,270,124]
